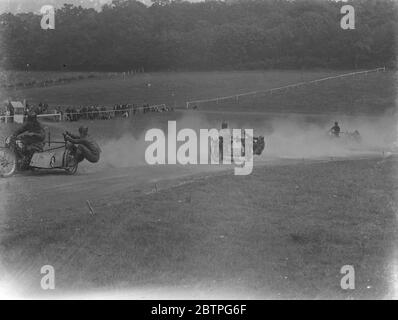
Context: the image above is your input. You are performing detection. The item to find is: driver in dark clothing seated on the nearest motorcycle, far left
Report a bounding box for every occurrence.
[12,111,46,156]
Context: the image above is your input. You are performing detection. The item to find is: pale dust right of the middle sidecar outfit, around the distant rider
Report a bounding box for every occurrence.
[262,112,397,158]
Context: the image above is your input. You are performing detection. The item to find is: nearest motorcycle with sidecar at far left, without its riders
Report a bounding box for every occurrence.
[0,134,78,178]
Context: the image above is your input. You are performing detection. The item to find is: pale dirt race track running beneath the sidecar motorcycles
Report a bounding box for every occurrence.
[0,153,386,223]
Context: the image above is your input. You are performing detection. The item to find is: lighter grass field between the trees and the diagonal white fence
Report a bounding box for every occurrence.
[1,71,352,106]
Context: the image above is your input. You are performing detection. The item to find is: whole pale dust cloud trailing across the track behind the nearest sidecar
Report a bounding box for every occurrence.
[85,112,397,171]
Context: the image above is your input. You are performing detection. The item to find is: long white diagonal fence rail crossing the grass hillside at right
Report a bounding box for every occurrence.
[186,67,386,109]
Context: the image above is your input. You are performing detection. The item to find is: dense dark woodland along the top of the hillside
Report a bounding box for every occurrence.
[0,0,398,70]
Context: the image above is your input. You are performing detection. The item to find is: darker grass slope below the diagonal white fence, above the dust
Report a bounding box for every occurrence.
[198,71,398,116]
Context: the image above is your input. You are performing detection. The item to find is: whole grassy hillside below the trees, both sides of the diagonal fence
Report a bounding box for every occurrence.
[0,71,397,115]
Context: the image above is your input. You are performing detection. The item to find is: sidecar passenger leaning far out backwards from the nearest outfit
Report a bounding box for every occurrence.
[64,127,101,163]
